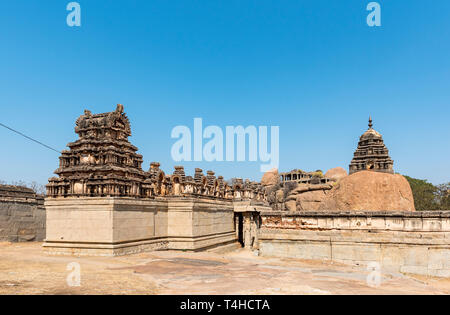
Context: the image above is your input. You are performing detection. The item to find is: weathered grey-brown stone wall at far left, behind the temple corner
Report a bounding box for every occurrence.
[0,185,45,242]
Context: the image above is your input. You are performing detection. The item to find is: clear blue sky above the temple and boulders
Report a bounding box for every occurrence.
[0,0,450,184]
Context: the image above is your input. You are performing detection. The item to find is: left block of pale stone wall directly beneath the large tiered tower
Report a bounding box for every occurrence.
[44,197,168,256]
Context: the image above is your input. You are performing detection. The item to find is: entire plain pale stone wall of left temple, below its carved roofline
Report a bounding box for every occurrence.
[44,196,241,256]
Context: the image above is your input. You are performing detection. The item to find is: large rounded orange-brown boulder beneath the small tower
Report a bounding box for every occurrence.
[319,171,415,211]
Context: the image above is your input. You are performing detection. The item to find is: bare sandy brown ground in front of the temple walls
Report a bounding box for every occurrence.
[0,243,450,295]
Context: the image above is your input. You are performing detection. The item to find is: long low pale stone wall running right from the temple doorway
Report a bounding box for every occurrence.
[259,211,450,277]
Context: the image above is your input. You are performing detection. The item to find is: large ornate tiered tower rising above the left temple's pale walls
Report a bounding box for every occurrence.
[47,104,146,196]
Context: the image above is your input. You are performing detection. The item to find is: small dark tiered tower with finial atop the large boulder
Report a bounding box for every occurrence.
[349,117,394,174]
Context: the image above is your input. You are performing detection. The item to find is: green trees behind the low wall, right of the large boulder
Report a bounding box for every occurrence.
[405,176,450,211]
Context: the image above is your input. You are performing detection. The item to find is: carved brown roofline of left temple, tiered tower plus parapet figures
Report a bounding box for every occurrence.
[47,104,266,201]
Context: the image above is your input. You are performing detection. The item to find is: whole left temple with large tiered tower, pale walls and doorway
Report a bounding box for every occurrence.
[44,104,270,256]
